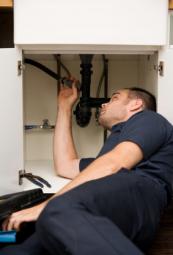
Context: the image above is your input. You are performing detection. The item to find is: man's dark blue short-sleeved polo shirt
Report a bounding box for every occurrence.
[79,110,173,195]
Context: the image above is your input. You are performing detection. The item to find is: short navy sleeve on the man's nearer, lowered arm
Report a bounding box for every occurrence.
[119,111,166,159]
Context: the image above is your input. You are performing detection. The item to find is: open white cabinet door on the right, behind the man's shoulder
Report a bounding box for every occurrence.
[158,49,173,124]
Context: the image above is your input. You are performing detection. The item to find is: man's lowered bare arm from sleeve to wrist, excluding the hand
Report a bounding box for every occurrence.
[54,141,143,197]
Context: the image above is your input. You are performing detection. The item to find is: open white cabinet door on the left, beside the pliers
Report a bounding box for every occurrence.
[0,48,23,195]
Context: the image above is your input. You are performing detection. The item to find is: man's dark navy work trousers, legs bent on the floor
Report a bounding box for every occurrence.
[0,169,167,255]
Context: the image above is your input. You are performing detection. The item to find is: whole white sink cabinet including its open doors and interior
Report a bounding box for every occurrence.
[0,0,173,194]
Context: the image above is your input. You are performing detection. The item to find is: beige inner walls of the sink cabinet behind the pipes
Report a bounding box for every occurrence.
[23,52,158,171]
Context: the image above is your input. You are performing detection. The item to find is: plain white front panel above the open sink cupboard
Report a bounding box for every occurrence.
[14,0,168,51]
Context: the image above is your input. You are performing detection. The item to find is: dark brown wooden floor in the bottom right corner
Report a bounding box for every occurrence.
[146,200,173,255]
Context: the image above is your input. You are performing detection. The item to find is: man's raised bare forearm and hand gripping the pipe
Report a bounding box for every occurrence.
[53,82,79,179]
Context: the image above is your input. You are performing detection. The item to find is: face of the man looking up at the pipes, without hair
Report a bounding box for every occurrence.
[99,89,130,129]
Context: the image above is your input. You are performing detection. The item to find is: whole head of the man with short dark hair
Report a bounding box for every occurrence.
[99,87,156,129]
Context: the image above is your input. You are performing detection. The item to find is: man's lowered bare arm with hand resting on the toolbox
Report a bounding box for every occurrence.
[3,141,143,230]
